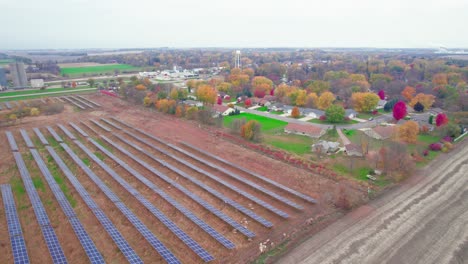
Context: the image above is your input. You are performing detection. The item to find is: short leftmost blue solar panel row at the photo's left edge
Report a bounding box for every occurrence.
[0,184,29,264]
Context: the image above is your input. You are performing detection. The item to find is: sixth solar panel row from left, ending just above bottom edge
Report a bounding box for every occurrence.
[64,131,218,261]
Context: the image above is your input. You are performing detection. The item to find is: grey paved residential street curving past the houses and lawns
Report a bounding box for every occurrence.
[236,106,393,129]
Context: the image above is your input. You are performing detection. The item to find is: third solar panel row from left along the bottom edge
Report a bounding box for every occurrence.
[30,146,105,263]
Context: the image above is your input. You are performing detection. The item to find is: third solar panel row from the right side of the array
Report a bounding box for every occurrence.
[105,119,273,227]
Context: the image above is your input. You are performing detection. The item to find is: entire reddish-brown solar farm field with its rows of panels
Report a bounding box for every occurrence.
[0,95,364,263]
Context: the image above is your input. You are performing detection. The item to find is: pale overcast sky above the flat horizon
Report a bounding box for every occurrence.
[0,0,468,50]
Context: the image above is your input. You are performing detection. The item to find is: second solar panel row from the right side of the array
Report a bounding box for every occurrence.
[120,129,289,218]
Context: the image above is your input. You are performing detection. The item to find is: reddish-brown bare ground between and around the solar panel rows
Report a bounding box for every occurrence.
[0,95,367,263]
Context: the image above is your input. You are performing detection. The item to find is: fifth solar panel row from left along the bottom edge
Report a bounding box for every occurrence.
[60,140,188,263]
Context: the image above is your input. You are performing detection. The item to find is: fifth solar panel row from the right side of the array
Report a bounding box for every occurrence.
[86,134,241,249]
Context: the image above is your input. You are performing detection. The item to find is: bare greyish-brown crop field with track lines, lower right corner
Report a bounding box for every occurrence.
[277,140,468,264]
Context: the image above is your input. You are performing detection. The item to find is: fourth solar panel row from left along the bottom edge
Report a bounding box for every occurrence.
[46,146,143,263]
